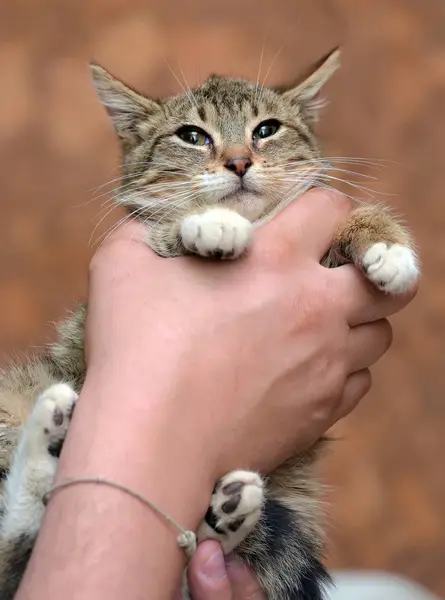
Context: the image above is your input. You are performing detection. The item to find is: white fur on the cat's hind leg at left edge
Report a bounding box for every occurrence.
[1,383,77,539]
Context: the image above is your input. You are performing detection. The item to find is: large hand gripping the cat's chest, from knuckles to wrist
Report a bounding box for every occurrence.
[87,190,413,480]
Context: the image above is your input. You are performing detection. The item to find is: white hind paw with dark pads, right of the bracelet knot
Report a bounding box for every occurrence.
[198,471,264,553]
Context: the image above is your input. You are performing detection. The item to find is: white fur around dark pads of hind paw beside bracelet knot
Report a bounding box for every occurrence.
[197,471,264,554]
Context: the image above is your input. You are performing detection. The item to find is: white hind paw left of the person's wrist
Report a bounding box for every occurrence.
[24,383,78,456]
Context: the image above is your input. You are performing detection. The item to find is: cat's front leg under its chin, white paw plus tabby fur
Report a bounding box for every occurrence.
[147,206,253,259]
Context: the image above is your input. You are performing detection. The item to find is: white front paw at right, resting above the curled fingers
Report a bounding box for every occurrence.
[362,242,420,294]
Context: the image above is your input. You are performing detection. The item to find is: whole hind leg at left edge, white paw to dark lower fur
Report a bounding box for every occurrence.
[0,383,77,600]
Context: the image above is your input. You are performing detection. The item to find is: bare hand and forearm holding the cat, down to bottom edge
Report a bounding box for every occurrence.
[17,191,413,600]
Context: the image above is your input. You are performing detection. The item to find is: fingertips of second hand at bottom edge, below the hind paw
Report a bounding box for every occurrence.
[175,541,266,600]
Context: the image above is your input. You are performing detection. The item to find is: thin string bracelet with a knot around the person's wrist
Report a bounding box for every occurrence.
[42,477,196,559]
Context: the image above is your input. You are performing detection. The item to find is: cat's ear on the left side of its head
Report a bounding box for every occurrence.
[91,64,161,142]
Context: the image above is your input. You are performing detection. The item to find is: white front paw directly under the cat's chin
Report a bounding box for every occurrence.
[181,208,252,258]
